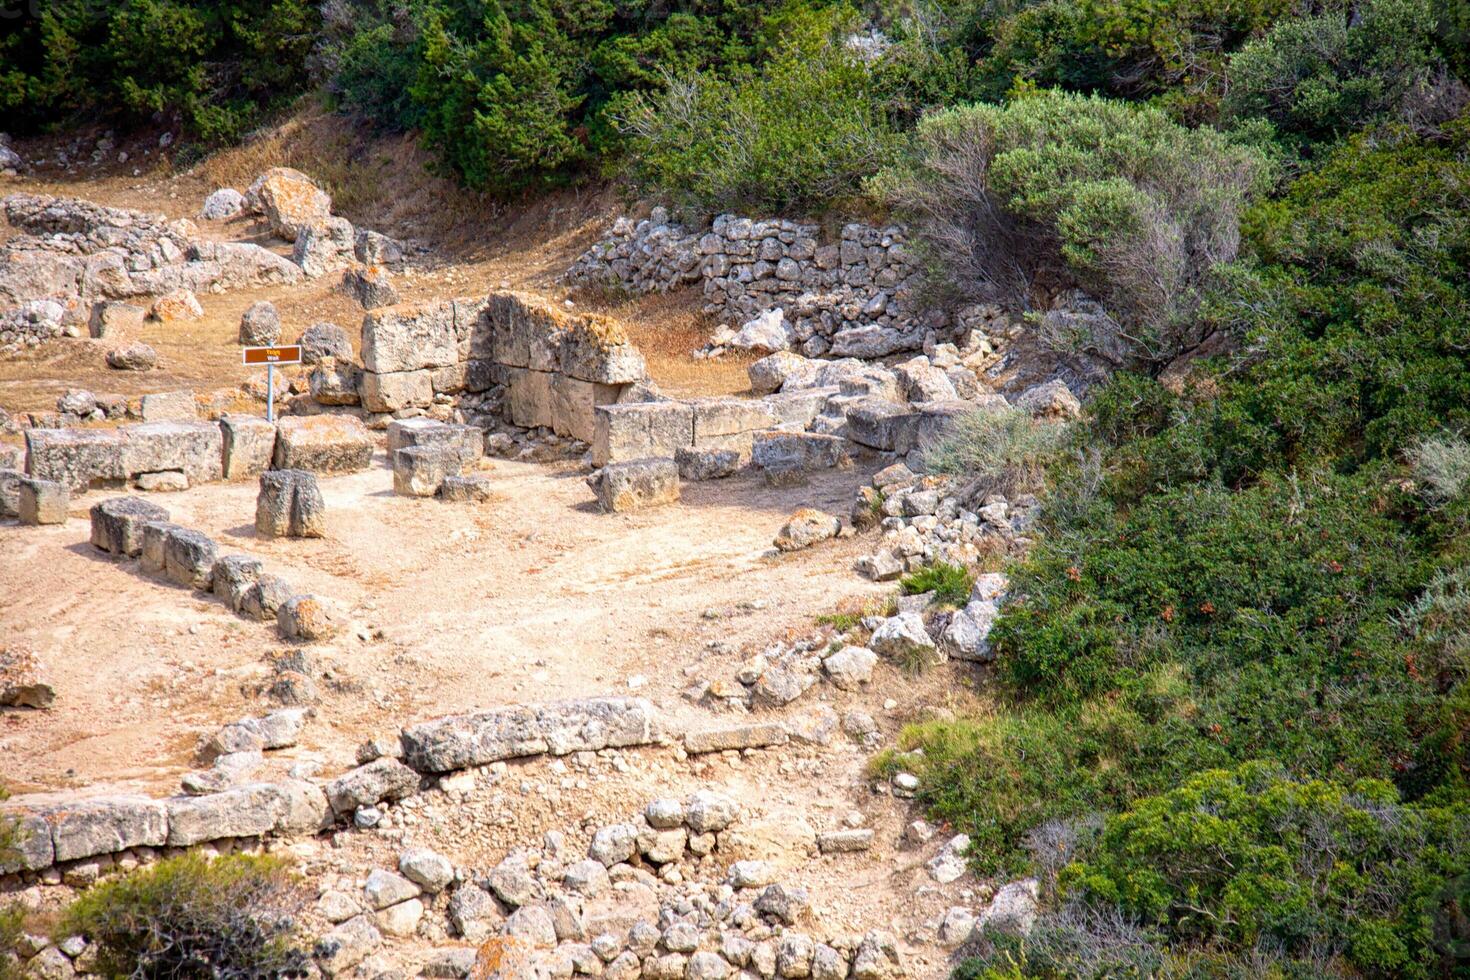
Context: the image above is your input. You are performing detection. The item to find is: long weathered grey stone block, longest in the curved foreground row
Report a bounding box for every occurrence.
[403,698,657,773]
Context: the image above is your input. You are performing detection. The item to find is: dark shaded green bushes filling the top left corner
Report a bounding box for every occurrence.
[0,0,319,143]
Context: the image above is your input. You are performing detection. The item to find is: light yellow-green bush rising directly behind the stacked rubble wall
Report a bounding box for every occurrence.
[622,8,898,213]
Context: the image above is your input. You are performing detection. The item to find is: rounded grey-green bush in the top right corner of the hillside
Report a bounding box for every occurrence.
[1223,0,1466,151]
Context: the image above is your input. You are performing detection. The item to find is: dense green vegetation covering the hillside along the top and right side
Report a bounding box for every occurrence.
[0,0,1470,979]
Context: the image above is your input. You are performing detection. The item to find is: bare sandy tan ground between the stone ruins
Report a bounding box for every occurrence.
[0,116,999,977]
